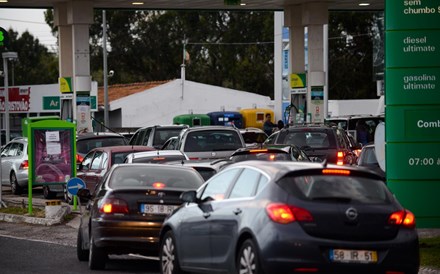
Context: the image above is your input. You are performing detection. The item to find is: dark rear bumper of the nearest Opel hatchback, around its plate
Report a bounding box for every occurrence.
[257,226,420,274]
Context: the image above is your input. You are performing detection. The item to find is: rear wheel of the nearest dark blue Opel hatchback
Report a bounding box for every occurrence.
[236,239,263,274]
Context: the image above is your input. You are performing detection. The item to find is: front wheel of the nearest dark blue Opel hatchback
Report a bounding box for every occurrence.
[159,230,185,274]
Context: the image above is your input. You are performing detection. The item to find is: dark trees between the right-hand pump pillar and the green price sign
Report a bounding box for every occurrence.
[328,11,377,99]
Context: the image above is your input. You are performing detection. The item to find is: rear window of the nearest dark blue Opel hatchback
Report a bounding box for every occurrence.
[279,175,390,204]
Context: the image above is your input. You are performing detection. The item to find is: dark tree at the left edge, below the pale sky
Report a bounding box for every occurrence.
[2,29,59,86]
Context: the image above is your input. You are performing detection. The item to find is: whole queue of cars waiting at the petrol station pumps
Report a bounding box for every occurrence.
[2,119,410,273]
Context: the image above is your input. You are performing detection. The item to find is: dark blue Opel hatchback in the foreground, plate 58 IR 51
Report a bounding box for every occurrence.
[159,161,419,274]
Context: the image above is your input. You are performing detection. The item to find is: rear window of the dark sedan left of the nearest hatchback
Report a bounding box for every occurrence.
[109,164,203,189]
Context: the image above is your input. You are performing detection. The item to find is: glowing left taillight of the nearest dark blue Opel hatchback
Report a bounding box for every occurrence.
[266,203,313,224]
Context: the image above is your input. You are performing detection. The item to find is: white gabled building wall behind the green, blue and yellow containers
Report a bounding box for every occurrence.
[110,79,274,127]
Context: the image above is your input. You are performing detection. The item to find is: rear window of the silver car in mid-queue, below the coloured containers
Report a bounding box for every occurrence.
[184,130,243,152]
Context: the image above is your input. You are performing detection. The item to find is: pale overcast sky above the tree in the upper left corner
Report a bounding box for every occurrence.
[0,8,57,51]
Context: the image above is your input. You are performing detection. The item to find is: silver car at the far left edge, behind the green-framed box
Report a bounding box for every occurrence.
[1,137,28,195]
